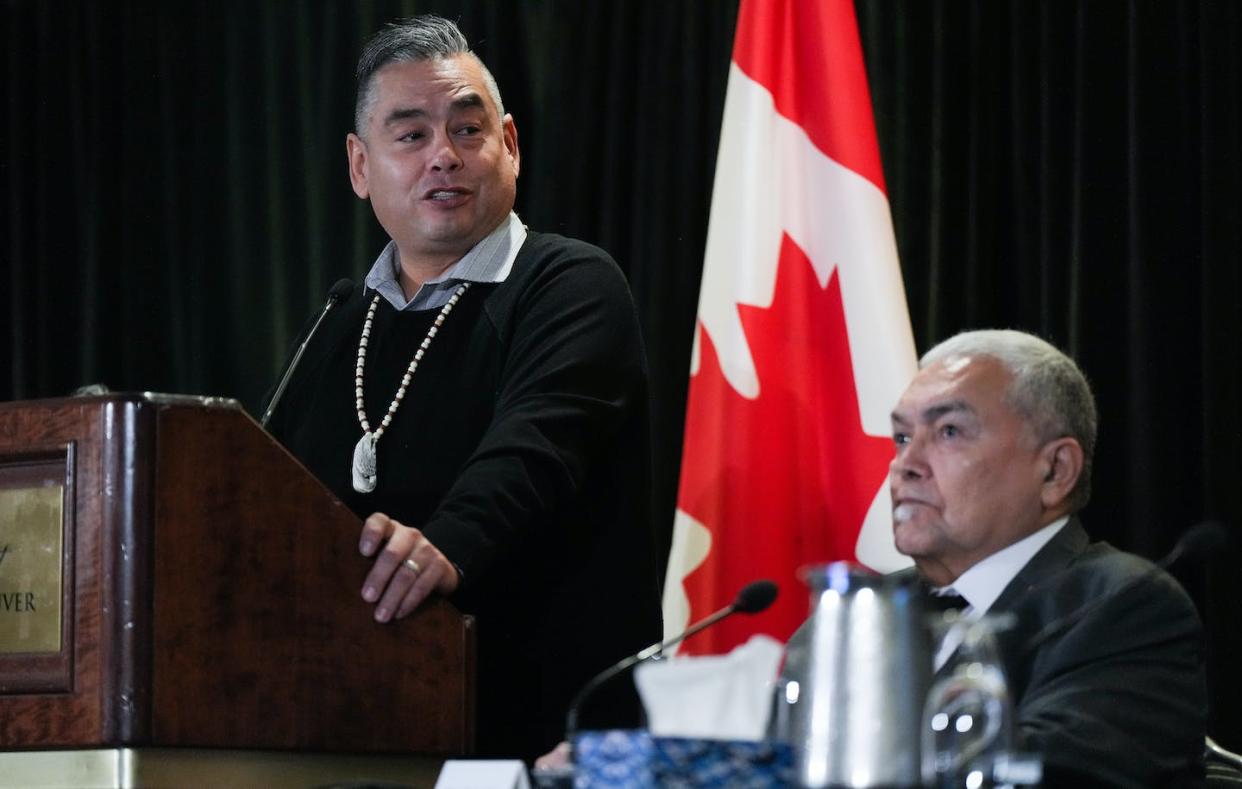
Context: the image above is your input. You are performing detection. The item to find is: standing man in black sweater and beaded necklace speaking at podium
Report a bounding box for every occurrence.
[270,16,661,758]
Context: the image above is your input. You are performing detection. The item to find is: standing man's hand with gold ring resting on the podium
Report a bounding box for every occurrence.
[358,512,461,623]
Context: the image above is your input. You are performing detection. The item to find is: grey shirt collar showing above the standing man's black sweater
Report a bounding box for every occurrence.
[366,211,527,311]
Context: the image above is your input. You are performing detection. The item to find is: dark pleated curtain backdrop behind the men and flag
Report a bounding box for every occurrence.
[0,0,1242,748]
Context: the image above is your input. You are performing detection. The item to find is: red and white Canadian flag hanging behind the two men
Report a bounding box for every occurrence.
[664,0,915,654]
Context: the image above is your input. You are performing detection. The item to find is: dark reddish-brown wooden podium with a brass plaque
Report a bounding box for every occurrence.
[0,394,474,785]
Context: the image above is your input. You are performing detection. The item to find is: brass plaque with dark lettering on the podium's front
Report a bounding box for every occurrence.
[0,485,65,655]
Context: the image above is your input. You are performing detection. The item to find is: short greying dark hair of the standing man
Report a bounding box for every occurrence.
[354,14,504,137]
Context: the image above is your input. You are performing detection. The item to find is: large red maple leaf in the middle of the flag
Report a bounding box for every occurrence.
[678,235,893,654]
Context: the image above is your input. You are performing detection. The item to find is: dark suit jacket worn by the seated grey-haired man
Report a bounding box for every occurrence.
[989,518,1207,787]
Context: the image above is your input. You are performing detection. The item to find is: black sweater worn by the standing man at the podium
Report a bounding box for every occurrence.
[270,232,661,758]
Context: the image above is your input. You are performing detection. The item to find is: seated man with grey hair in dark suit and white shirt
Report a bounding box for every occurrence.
[891,331,1207,787]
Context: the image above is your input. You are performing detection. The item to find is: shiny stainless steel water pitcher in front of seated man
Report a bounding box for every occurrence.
[773,562,932,788]
